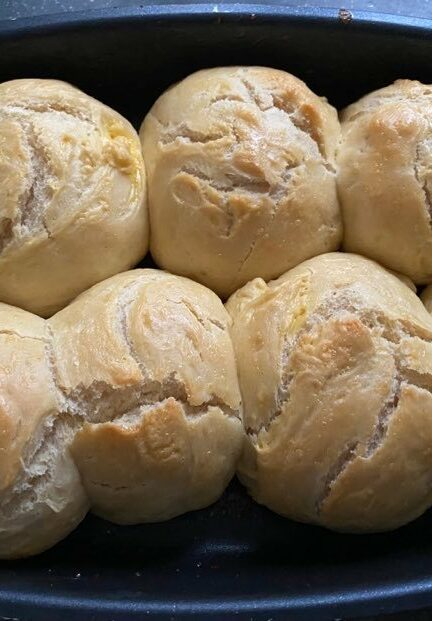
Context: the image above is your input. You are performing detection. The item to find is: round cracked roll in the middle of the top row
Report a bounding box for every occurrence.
[140,67,342,297]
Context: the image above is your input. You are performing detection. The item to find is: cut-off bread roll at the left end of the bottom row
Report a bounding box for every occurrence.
[0,304,89,558]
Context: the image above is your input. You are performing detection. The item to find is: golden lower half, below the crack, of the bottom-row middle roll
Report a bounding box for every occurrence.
[69,397,241,524]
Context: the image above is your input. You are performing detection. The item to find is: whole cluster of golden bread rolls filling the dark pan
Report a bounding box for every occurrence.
[4,67,432,558]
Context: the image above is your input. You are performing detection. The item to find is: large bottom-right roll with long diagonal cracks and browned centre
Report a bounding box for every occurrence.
[227,253,432,532]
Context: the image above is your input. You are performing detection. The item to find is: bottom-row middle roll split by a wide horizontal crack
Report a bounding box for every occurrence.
[49,270,243,524]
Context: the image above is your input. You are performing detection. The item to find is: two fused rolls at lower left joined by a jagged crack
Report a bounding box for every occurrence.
[0,270,243,558]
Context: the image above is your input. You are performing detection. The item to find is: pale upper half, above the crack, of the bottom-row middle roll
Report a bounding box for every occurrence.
[48,269,240,410]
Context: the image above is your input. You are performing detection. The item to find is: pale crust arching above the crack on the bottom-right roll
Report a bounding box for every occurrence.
[227,253,432,427]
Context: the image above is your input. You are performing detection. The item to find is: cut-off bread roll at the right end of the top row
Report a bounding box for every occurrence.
[338,80,432,283]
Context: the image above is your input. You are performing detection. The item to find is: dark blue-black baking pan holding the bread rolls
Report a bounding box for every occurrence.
[0,4,432,621]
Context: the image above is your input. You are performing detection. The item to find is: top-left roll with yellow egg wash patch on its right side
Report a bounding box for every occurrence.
[0,79,148,317]
